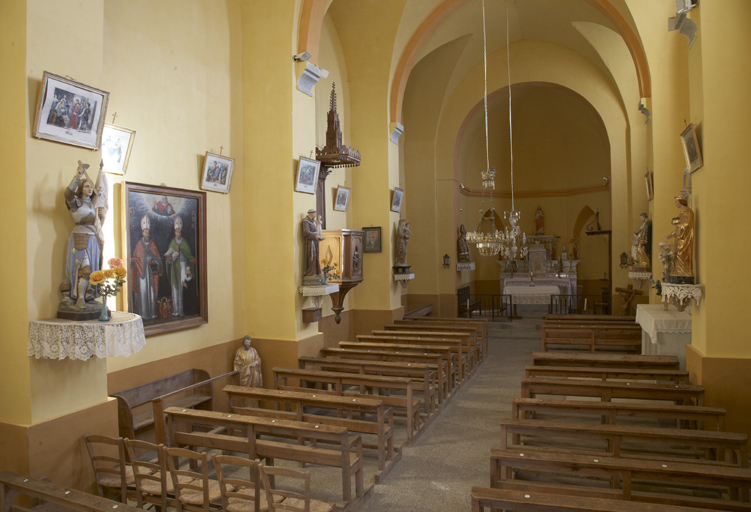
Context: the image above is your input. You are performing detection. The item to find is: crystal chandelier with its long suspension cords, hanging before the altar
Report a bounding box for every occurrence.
[467,0,528,260]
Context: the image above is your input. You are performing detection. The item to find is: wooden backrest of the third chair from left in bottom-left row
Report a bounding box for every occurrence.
[164,448,216,512]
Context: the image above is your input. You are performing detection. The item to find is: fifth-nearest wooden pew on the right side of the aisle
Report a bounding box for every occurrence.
[521,377,704,405]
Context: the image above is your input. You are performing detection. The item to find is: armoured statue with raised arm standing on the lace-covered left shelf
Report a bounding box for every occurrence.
[58,160,108,320]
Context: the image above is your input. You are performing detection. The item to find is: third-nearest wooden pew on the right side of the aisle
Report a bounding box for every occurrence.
[500,419,748,467]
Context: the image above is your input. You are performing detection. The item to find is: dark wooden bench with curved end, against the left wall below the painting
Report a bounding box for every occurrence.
[110,368,238,443]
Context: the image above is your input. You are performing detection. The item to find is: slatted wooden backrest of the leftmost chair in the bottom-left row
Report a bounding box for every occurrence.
[83,434,129,503]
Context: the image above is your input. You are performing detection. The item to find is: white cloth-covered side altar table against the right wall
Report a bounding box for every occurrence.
[636,304,691,370]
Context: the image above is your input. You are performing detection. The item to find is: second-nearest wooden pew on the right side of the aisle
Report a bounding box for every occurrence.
[490,448,751,511]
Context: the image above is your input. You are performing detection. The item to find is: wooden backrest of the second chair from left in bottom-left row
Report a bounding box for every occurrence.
[125,439,170,510]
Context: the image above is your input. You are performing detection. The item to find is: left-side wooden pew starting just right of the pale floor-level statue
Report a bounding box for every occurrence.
[272,366,428,443]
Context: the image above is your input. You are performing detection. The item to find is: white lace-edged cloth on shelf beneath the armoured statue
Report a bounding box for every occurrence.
[27,311,146,361]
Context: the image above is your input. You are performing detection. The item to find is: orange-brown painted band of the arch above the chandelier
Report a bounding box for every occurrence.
[390,0,652,123]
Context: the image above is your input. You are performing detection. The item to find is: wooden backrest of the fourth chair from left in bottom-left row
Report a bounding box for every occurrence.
[211,455,266,512]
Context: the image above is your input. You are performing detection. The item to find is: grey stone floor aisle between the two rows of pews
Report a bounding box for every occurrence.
[360,319,542,512]
